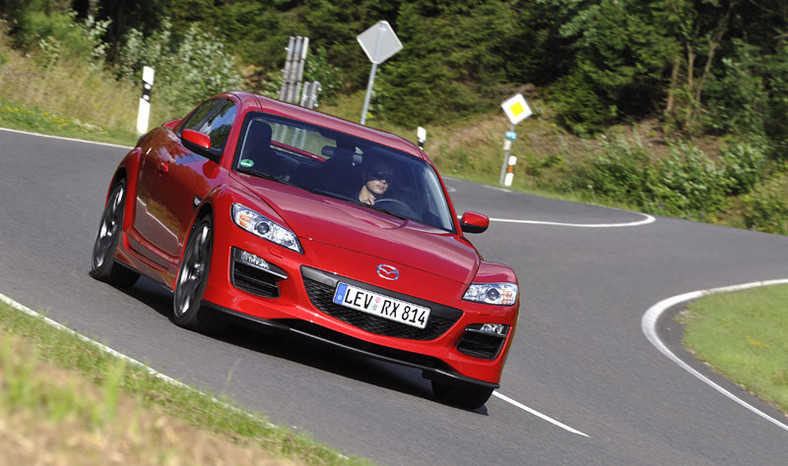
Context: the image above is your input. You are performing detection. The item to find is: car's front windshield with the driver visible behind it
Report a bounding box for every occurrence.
[236,114,454,231]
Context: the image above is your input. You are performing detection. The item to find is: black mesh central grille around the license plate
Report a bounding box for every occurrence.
[302,267,462,340]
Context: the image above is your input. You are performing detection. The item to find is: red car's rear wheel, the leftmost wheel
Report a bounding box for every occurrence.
[90,179,140,288]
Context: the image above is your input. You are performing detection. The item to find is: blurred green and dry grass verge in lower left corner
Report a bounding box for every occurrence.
[0,296,369,465]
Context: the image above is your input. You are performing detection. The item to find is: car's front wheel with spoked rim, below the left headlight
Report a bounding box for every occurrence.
[170,216,224,333]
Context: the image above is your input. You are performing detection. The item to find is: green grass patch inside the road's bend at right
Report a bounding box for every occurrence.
[681,285,788,414]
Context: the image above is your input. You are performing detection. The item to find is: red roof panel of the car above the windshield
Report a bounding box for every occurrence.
[227,91,428,160]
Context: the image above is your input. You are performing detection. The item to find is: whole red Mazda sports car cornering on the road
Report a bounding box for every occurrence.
[91,92,519,409]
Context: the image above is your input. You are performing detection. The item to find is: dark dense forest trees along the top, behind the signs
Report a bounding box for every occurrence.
[0,0,788,142]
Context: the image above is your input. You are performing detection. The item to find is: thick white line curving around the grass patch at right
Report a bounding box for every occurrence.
[641,279,788,431]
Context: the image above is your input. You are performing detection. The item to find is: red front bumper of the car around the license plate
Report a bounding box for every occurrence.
[203,226,519,388]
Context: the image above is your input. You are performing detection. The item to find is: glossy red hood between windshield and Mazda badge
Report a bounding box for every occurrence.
[234,175,481,284]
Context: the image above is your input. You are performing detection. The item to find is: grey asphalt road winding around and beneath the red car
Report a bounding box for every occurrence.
[0,130,788,466]
